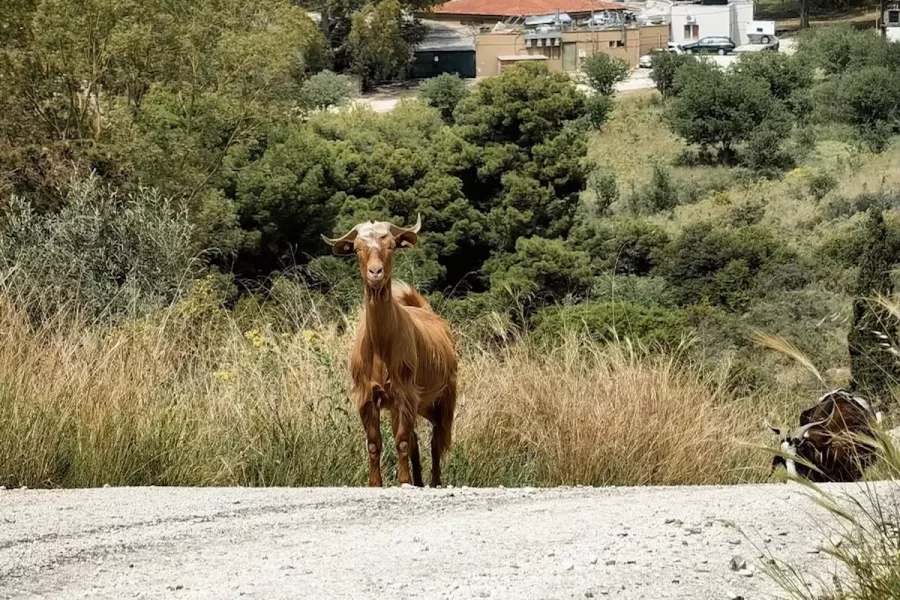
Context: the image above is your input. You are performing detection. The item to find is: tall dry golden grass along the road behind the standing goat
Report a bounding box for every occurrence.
[0,284,768,487]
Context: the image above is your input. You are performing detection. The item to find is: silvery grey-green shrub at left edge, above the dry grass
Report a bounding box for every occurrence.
[0,178,202,319]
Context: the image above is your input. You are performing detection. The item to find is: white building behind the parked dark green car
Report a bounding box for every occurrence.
[670,0,754,46]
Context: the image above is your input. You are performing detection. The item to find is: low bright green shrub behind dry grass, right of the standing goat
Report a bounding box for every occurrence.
[532,302,689,347]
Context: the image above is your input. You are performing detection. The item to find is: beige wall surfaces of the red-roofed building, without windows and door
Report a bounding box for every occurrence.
[475,25,669,77]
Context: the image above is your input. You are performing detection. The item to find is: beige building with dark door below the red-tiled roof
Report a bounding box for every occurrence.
[475,25,669,77]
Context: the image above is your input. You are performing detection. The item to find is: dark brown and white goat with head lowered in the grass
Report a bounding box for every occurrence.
[769,389,881,482]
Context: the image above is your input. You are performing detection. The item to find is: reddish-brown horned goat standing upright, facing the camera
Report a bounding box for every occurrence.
[322,216,458,487]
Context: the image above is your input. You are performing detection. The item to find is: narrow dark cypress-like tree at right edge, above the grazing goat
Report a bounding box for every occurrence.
[847,207,897,409]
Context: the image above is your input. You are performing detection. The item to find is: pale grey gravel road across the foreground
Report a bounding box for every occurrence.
[0,484,876,600]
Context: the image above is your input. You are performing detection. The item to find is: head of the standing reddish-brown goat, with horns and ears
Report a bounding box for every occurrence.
[322,215,422,291]
